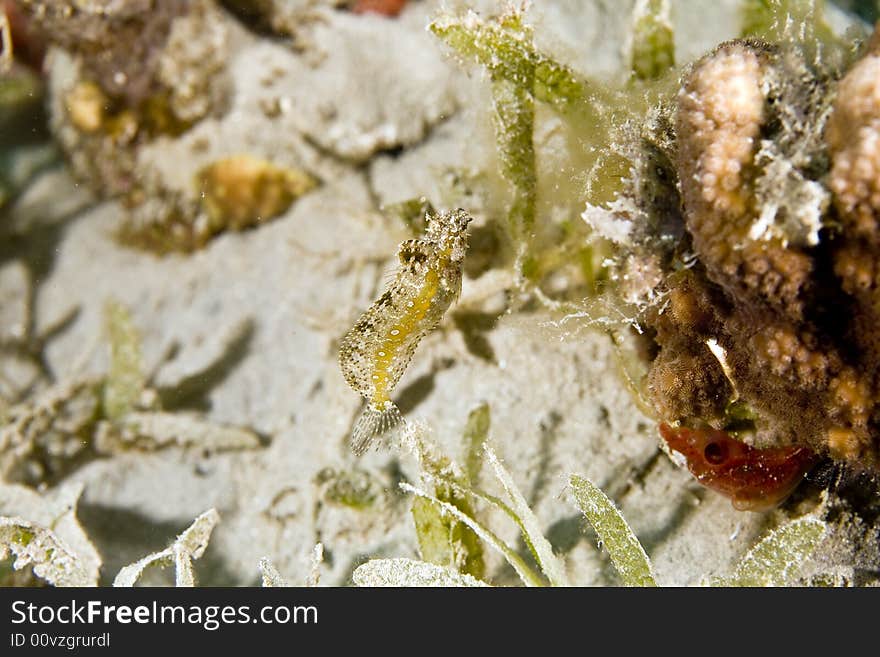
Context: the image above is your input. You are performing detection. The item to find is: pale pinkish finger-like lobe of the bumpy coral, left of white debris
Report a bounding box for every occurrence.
[677,42,811,317]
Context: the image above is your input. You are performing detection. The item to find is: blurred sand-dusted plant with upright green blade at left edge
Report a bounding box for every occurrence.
[0,300,262,486]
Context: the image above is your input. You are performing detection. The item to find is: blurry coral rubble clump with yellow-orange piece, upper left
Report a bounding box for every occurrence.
[23,0,324,252]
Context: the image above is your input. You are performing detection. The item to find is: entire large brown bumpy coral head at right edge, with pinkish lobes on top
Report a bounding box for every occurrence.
[632,29,880,476]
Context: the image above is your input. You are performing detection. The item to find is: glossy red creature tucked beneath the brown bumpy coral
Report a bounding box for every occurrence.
[660,423,818,511]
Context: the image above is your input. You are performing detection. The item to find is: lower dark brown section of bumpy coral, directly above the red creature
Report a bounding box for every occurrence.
[645,267,873,461]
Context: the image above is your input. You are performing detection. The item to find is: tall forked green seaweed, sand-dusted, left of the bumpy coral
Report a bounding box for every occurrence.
[429,10,640,285]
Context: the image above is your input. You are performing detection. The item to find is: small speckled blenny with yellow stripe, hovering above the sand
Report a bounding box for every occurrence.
[339,209,472,454]
